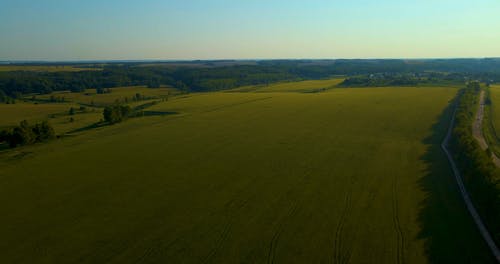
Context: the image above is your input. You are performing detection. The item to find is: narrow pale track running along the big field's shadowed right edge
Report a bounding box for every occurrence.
[441,94,500,263]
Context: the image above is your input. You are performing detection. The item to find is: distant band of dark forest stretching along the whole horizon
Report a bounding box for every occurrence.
[0,59,500,101]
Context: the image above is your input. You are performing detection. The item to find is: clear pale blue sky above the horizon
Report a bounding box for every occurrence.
[0,0,500,60]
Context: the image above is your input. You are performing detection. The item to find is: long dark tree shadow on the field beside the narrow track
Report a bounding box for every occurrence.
[417,93,494,263]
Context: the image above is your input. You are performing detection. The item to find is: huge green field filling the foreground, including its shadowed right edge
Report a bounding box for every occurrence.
[0,83,492,263]
